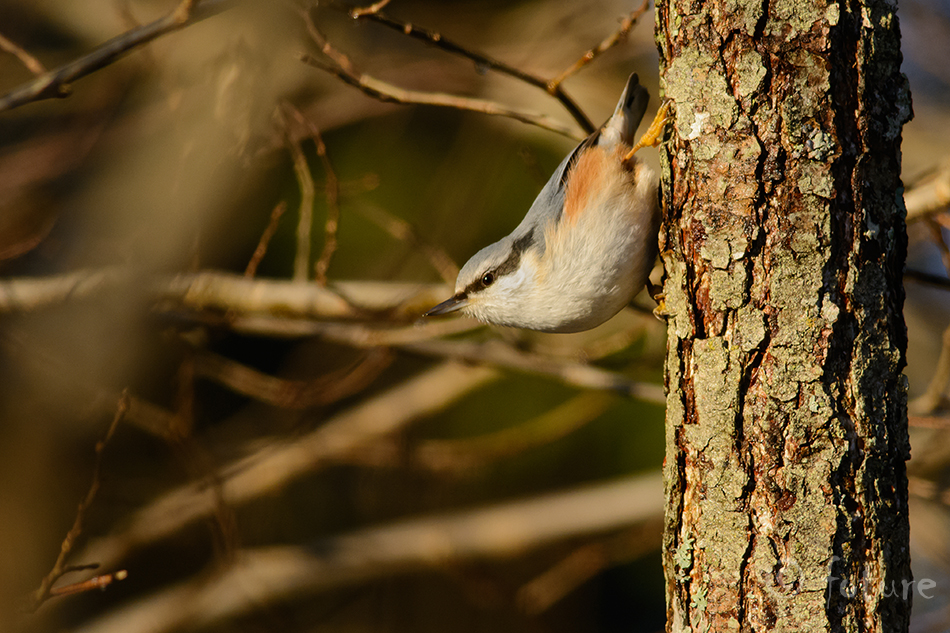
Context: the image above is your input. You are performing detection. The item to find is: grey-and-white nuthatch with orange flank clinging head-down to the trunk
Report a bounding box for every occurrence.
[425,73,666,332]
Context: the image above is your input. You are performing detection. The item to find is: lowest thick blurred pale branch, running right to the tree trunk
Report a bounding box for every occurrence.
[83,474,663,633]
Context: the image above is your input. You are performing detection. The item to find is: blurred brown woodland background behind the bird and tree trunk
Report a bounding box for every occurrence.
[0,0,950,633]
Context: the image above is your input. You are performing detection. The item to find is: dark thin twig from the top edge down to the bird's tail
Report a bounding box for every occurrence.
[329,2,596,134]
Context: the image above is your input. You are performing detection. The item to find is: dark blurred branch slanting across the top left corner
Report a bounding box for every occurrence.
[0,0,235,112]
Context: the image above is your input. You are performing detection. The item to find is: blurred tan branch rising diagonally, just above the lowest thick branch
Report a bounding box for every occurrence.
[76,362,498,566]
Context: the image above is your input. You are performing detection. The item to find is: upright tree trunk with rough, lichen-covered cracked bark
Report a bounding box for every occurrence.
[657,0,922,631]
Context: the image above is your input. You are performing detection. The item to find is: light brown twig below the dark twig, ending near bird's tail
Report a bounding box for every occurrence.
[300,54,578,140]
